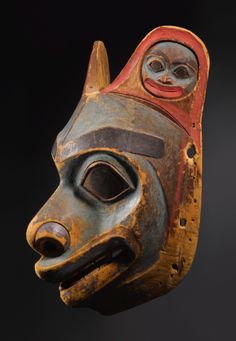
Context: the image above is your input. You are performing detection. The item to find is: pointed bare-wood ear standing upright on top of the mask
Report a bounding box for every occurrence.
[83,41,110,95]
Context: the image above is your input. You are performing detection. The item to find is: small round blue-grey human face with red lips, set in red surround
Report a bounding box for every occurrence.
[142,41,198,99]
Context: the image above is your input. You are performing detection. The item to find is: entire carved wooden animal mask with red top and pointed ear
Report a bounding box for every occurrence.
[27,26,209,314]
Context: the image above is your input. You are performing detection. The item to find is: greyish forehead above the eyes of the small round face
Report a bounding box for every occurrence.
[146,41,198,66]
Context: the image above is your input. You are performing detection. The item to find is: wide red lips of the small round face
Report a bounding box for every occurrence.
[144,78,183,98]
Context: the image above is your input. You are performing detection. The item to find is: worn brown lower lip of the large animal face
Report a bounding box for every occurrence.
[59,261,127,306]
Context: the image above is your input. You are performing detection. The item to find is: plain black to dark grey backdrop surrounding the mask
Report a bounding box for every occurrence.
[0,0,236,341]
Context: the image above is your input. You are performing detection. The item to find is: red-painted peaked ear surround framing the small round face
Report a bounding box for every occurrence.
[102,26,209,151]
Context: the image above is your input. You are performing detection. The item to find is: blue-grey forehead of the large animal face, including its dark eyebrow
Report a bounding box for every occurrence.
[53,94,188,161]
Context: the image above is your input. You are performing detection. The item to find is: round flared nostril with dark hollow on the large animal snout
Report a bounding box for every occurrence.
[34,222,70,258]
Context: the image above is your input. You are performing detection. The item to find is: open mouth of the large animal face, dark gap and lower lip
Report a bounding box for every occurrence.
[55,237,137,306]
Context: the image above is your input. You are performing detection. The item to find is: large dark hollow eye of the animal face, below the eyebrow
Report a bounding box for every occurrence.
[82,163,132,201]
